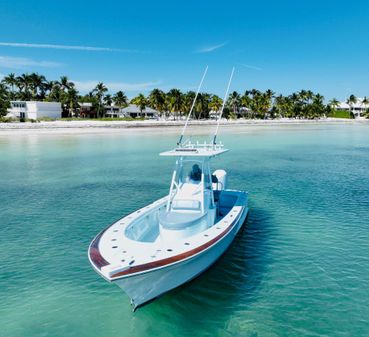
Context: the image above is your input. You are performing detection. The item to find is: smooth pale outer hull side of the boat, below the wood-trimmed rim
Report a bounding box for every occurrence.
[112,206,248,309]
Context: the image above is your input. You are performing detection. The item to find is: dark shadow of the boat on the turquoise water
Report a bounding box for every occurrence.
[134,205,274,324]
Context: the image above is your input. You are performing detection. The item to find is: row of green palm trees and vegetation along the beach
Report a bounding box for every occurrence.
[0,73,369,119]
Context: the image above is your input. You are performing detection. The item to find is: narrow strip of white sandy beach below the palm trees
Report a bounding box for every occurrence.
[0,118,369,136]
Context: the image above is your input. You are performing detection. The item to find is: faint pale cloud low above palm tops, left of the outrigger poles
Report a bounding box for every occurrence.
[73,81,161,92]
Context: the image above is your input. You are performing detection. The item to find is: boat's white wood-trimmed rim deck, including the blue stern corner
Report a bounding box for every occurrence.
[89,190,247,281]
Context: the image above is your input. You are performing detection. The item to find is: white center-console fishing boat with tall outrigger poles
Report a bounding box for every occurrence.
[88,66,248,310]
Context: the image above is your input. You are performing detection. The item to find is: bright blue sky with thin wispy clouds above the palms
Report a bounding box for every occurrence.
[0,0,369,100]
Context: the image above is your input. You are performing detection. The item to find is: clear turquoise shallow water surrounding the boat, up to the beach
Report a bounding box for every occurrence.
[0,125,369,337]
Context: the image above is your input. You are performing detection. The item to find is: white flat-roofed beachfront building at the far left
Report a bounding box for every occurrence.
[6,101,62,119]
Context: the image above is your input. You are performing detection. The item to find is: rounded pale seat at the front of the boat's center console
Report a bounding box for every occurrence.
[159,209,207,230]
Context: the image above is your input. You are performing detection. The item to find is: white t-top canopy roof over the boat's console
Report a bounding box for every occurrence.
[160,142,229,158]
